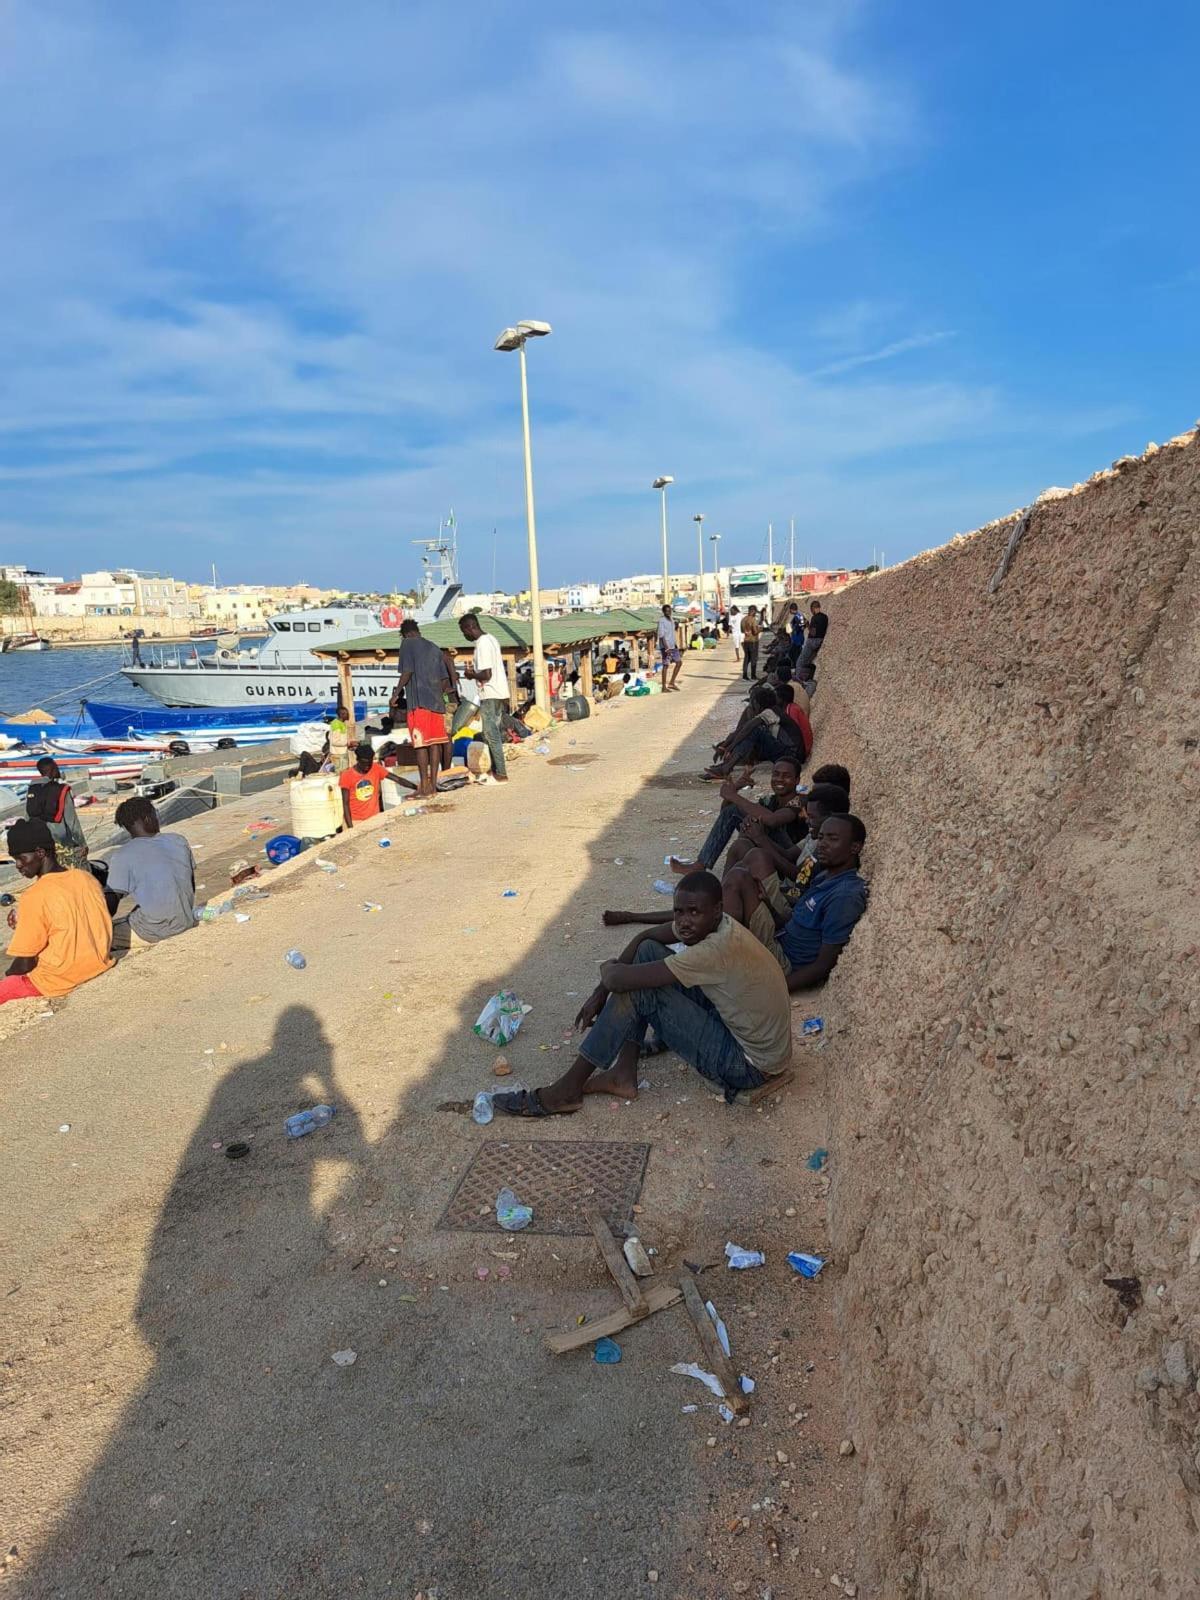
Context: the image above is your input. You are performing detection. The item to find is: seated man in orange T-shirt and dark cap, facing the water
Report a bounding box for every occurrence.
[0,818,112,1005]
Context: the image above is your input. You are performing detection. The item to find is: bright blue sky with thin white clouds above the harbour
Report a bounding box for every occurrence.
[0,0,1200,587]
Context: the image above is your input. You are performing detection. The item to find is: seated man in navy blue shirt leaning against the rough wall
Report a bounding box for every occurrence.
[725,816,867,994]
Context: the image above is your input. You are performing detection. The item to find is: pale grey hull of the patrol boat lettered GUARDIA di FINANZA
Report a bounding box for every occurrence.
[122,661,397,710]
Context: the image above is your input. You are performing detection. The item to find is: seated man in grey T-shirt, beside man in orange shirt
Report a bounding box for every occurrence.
[104,795,195,950]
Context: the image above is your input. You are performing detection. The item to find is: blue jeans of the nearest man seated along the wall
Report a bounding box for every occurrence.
[579,939,766,1101]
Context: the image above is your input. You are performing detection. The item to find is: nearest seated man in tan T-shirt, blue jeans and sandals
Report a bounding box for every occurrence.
[493,872,792,1117]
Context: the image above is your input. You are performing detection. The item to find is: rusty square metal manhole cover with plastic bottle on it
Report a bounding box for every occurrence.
[437,1139,650,1235]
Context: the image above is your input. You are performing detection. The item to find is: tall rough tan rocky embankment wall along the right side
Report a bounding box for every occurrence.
[821,419,1200,1600]
